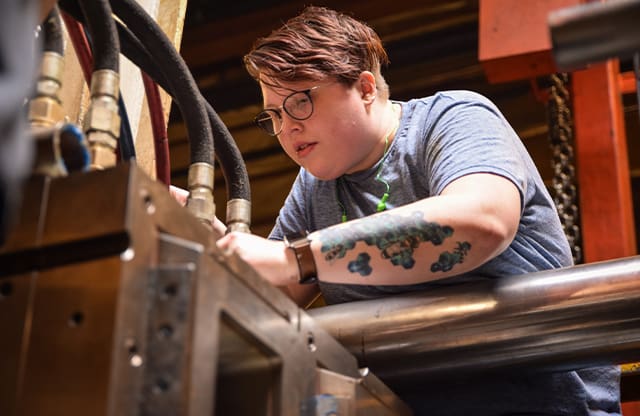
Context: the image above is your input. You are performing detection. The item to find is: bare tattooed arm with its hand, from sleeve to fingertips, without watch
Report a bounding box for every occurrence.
[217,174,520,290]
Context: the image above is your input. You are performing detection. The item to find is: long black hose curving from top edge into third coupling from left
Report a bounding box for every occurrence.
[111,0,214,166]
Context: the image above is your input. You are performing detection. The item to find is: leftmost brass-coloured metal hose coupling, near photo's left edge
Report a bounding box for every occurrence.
[29,52,65,127]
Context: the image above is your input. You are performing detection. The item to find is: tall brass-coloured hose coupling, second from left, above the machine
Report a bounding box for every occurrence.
[82,69,120,170]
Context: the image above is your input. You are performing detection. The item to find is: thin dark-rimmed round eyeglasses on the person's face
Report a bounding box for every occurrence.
[253,85,319,136]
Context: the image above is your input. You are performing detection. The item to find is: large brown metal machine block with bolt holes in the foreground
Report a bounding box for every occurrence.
[0,164,410,415]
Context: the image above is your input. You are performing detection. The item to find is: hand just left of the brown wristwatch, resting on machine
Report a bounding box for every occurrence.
[216,232,299,286]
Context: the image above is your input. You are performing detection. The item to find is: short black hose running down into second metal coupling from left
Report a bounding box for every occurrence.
[80,0,120,73]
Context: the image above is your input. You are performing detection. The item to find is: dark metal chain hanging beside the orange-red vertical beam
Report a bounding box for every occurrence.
[548,74,582,264]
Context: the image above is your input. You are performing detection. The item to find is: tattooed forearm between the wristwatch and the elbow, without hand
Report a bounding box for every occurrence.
[310,178,518,285]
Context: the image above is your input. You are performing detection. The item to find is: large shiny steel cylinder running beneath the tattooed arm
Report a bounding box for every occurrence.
[308,256,640,381]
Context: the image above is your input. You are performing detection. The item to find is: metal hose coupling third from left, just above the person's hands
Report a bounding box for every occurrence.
[187,162,216,227]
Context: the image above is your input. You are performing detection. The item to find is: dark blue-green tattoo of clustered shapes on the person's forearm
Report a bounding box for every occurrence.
[319,211,471,276]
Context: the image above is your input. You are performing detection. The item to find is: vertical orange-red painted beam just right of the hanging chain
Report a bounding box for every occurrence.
[572,60,636,263]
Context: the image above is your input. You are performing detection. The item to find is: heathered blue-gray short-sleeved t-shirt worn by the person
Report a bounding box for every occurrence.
[270,91,620,416]
